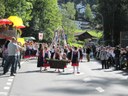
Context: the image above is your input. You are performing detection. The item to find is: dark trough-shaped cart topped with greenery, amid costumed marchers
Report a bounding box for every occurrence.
[46,59,69,69]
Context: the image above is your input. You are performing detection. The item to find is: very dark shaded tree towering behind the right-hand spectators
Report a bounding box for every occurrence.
[99,0,128,46]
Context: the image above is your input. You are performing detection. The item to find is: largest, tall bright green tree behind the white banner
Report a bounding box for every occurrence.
[23,0,61,42]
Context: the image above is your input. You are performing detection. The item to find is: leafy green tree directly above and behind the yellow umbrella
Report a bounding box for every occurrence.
[4,0,33,26]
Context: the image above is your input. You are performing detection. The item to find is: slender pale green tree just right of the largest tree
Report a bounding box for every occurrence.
[61,2,76,42]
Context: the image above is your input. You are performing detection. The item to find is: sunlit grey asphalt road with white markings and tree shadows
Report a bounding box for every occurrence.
[0,59,128,96]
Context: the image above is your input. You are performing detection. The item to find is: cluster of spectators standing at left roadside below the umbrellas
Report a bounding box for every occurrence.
[2,37,22,76]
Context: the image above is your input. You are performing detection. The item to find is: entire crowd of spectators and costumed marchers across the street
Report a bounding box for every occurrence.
[2,37,128,76]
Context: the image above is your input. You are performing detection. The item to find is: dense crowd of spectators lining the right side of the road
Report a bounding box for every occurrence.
[95,46,128,70]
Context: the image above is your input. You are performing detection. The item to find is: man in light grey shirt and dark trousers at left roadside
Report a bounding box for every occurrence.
[3,37,17,76]
